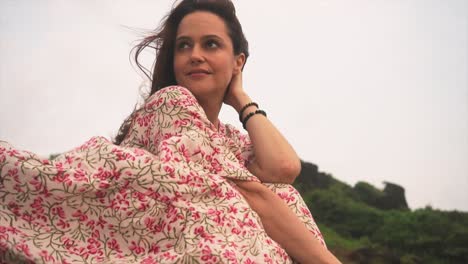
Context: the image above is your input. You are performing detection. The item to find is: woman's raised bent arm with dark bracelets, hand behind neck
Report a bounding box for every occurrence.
[224,73,301,184]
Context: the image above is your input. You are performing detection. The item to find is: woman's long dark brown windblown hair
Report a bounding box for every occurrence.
[114,0,249,145]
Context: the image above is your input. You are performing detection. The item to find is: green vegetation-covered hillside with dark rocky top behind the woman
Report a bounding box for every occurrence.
[295,162,468,264]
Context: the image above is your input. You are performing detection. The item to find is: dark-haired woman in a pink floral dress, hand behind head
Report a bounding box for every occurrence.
[0,0,338,263]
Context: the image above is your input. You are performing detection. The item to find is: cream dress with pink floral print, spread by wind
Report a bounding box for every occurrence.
[0,86,325,263]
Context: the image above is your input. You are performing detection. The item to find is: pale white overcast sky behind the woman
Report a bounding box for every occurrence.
[0,0,468,211]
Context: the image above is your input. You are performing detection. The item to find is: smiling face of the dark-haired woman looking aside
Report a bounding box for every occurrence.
[174,11,244,103]
